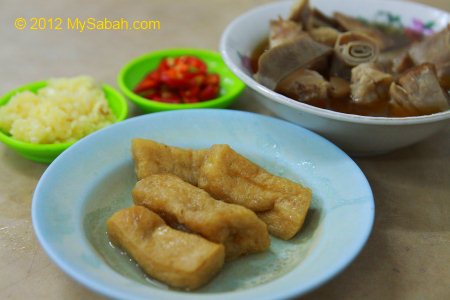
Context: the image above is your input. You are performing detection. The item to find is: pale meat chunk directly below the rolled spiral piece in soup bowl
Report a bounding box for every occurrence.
[350,63,393,106]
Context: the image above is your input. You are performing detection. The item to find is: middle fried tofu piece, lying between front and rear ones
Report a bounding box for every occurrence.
[132,174,270,259]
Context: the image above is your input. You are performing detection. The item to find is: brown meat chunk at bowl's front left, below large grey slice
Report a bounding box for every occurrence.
[275,69,329,103]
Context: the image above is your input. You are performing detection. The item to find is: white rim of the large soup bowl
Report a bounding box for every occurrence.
[219,0,450,126]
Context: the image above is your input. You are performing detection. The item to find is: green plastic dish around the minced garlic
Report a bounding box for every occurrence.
[0,81,128,163]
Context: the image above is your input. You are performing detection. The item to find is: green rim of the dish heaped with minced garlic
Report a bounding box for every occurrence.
[0,80,128,151]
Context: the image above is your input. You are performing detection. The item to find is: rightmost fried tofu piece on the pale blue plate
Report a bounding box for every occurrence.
[198,145,311,240]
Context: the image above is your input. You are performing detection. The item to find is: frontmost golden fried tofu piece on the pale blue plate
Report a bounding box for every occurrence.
[107,206,225,290]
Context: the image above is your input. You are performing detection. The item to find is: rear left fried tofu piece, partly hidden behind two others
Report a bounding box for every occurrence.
[131,139,207,185]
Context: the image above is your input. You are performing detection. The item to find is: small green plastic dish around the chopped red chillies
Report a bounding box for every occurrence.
[117,49,245,113]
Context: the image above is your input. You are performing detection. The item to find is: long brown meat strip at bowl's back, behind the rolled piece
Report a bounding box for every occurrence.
[333,12,394,50]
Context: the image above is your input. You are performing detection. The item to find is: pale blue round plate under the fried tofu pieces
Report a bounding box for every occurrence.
[32,110,374,300]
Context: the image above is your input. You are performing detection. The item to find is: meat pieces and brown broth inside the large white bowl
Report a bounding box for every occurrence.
[251,0,450,117]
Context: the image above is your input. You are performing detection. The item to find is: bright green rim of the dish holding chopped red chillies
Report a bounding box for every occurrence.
[117,48,245,110]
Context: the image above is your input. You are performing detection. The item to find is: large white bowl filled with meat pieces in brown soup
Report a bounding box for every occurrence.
[220,0,450,156]
